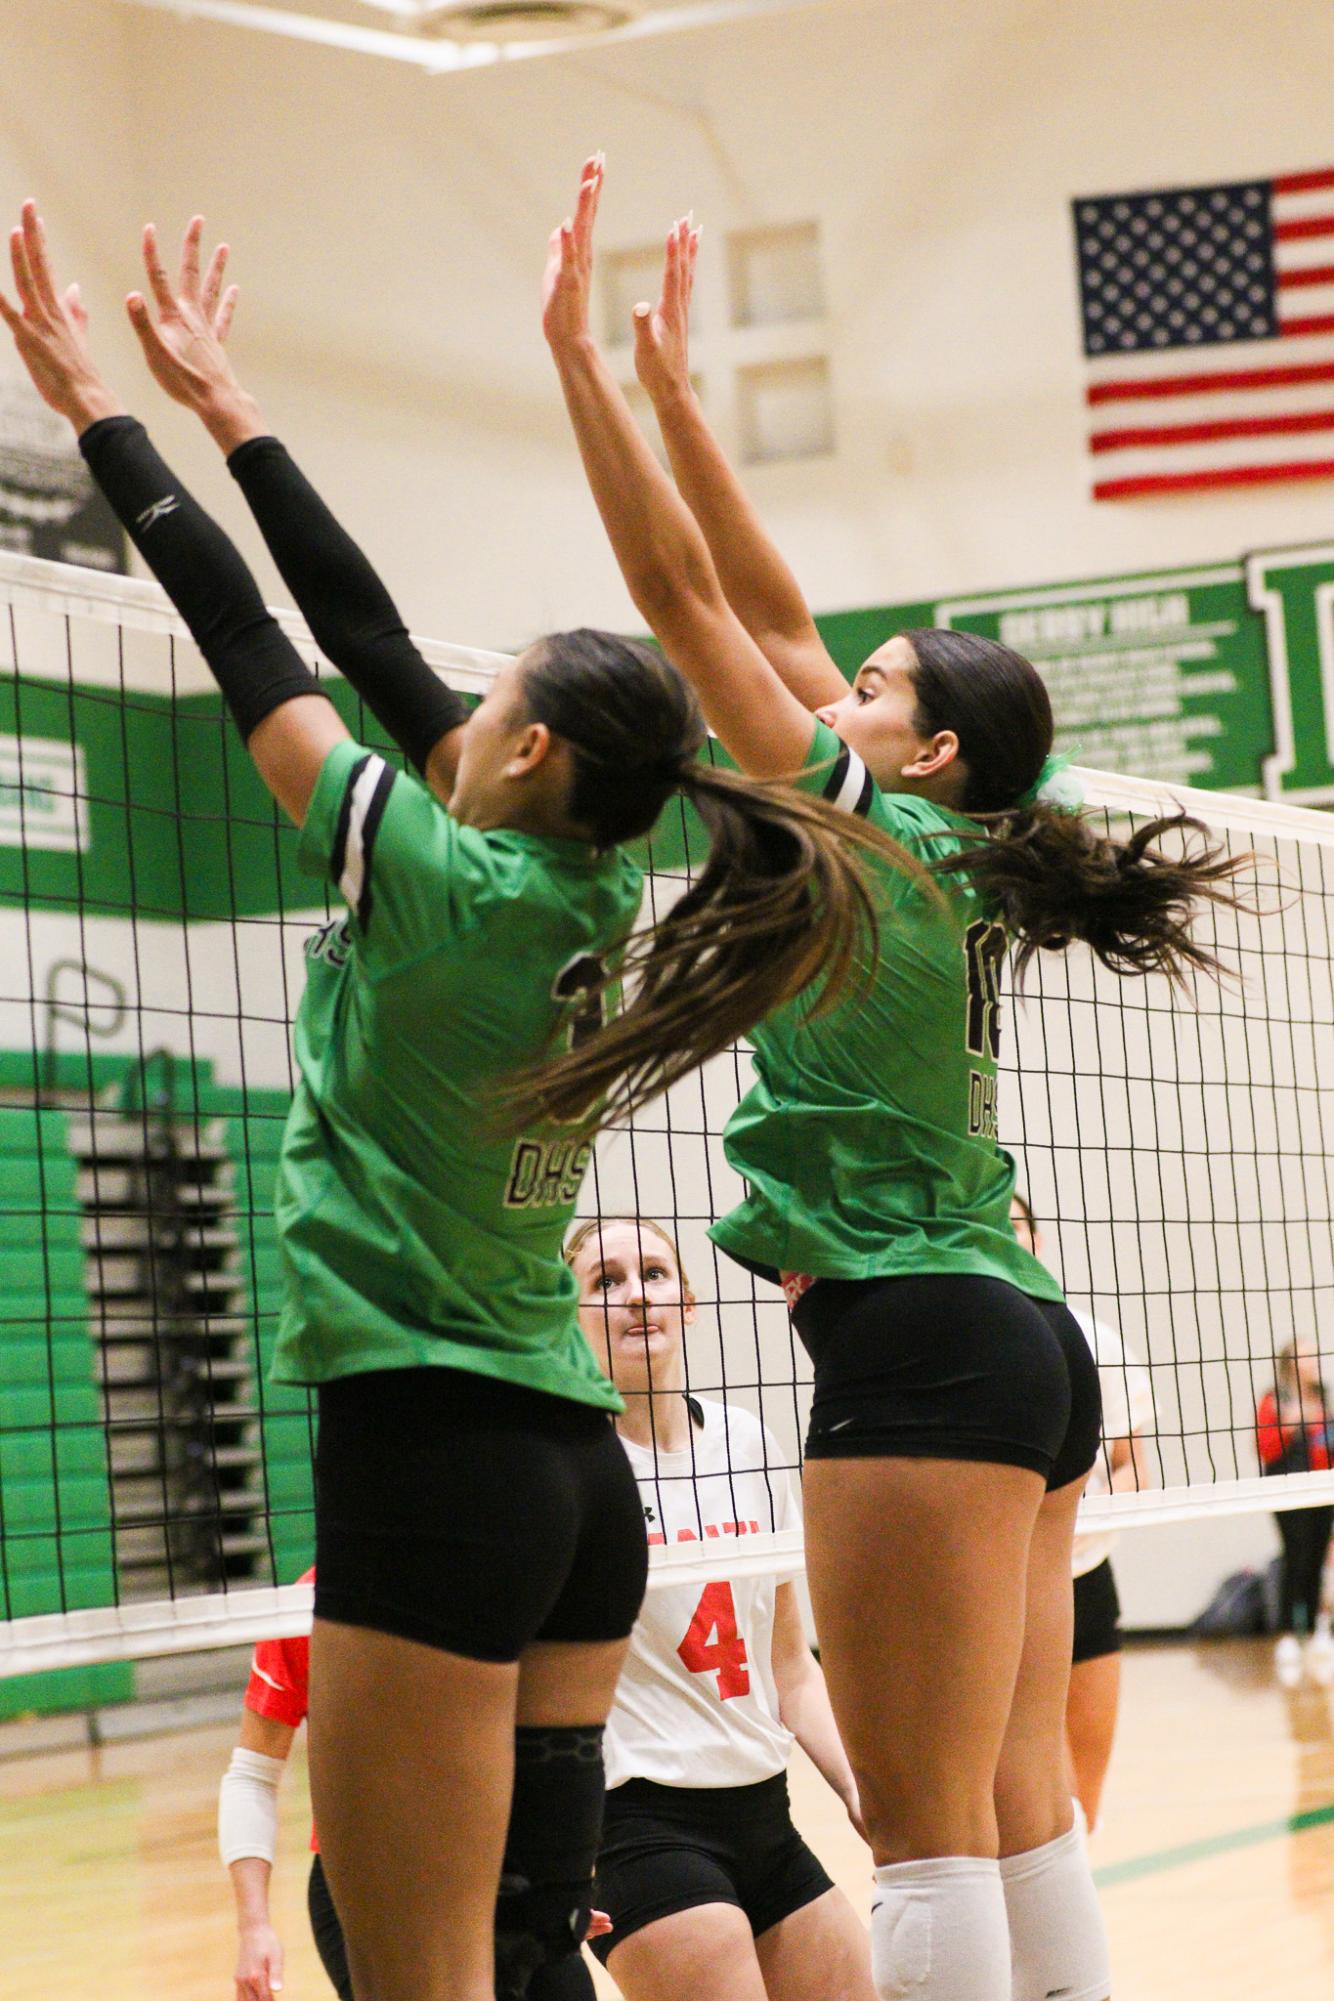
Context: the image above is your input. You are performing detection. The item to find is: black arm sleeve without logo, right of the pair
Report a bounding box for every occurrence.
[228,438,468,772]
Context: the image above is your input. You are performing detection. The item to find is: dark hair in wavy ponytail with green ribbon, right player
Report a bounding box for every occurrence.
[904,628,1254,984]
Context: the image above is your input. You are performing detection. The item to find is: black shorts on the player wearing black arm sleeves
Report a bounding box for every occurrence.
[314,1369,648,1661]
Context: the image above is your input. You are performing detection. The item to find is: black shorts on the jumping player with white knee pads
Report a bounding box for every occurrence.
[792,1273,1102,1489]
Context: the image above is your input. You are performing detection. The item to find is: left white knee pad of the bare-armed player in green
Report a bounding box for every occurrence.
[870,1855,1010,2001]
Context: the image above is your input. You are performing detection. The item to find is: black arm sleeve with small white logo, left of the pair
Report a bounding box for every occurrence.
[78,416,324,740]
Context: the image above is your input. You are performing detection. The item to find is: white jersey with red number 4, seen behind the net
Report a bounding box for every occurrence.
[606,1397,802,1787]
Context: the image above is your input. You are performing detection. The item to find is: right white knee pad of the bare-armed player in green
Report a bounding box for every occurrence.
[1000,1819,1112,2001]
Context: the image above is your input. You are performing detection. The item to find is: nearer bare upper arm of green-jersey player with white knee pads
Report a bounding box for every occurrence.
[646,592,814,778]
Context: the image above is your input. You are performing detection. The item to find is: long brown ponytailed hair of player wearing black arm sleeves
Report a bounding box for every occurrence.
[496,632,930,1129]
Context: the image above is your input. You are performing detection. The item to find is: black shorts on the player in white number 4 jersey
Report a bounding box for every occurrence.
[588,1771,834,1965]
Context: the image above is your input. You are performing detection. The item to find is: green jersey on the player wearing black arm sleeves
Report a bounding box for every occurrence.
[274,740,642,1411]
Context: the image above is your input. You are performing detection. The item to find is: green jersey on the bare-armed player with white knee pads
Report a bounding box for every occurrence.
[710,722,1062,1299]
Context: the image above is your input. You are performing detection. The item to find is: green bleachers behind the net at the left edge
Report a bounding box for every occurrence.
[0,1051,314,1719]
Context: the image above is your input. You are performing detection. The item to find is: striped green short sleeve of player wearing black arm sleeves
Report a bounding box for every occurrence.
[298,736,490,968]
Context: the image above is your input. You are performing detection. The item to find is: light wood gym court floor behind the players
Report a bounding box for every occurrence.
[0,1641,1334,2001]
